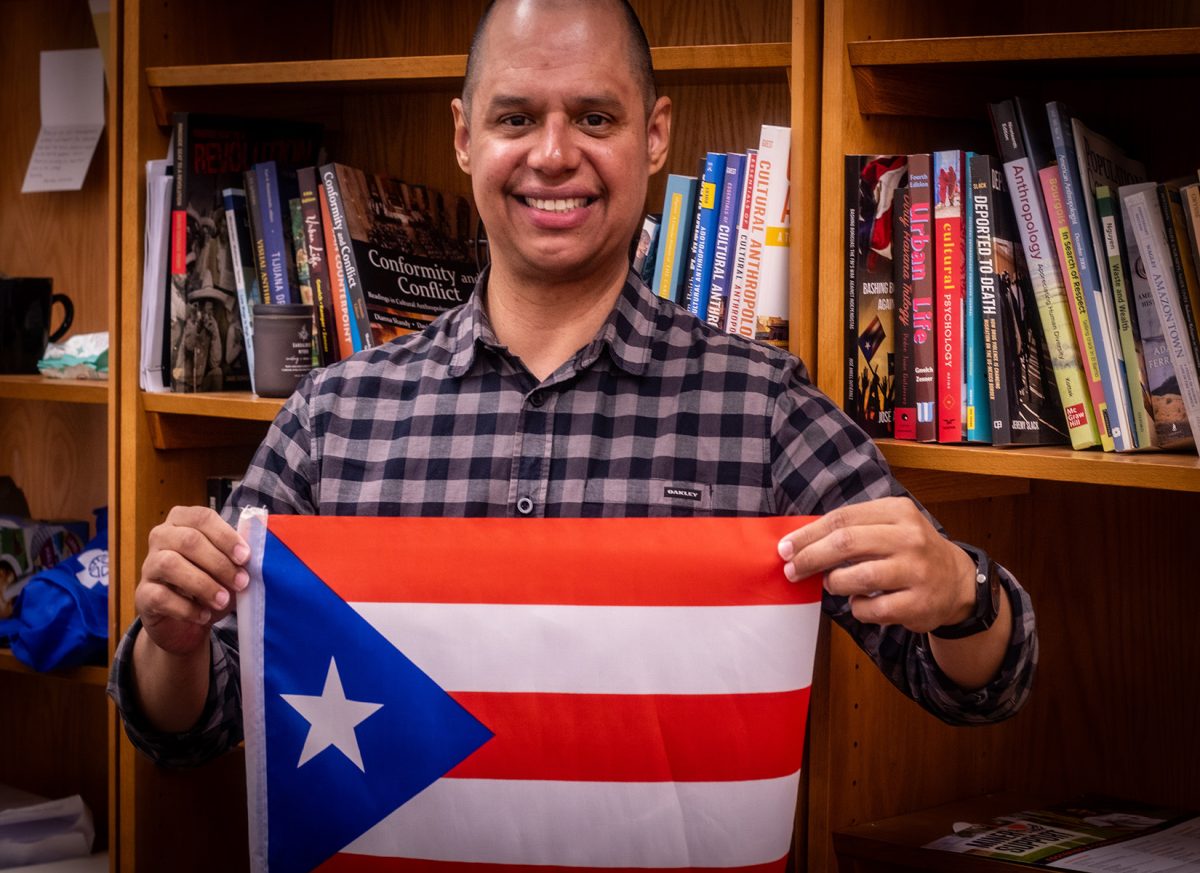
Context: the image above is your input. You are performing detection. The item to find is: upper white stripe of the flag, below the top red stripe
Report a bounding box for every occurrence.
[350,603,821,694]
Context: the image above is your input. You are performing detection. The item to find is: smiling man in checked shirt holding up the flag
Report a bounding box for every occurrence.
[113,0,1036,764]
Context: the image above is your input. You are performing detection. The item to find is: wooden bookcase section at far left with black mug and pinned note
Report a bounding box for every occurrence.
[0,0,118,849]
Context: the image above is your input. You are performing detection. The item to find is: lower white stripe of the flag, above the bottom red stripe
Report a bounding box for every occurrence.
[342,772,799,867]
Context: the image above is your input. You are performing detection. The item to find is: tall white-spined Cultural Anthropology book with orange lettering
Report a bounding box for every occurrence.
[746,125,792,349]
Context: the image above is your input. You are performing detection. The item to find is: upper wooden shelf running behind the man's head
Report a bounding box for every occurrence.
[146,42,792,126]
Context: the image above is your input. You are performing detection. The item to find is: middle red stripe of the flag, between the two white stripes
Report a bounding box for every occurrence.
[446,688,809,782]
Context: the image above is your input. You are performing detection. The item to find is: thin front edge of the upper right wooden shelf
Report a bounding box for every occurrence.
[846,28,1200,67]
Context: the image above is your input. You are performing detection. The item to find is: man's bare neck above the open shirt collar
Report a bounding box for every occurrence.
[486,259,628,381]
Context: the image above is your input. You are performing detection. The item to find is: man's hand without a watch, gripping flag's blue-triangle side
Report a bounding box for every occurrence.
[133,506,250,656]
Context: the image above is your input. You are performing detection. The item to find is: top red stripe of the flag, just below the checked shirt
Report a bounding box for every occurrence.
[268,516,821,606]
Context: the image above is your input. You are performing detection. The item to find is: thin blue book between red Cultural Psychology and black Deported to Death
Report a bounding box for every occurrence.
[962,151,995,442]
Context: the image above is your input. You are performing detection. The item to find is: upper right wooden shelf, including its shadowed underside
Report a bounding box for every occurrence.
[846,28,1200,118]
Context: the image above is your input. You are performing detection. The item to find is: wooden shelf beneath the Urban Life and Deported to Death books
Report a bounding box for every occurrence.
[877,440,1200,492]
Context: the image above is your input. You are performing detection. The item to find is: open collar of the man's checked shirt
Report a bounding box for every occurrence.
[449,267,660,378]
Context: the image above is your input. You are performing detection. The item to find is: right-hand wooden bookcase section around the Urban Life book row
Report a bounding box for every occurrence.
[806,0,1200,873]
